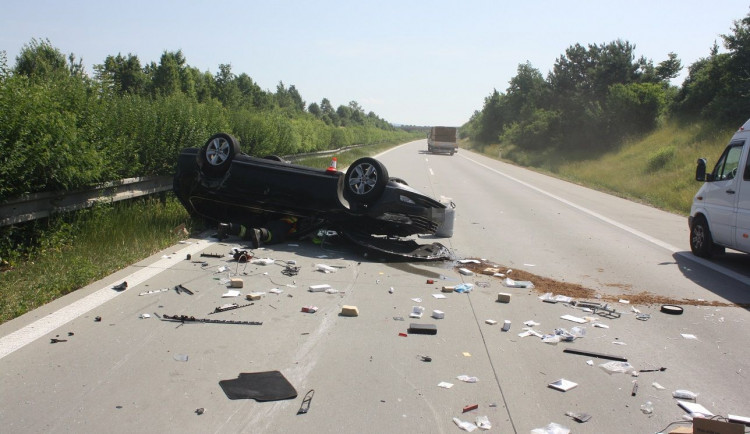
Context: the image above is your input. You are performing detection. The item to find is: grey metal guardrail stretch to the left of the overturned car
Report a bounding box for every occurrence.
[0,176,173,227]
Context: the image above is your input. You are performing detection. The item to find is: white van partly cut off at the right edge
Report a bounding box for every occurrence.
[688,120,750,258]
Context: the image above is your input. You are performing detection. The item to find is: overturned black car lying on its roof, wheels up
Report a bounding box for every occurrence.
[174,133,446,259]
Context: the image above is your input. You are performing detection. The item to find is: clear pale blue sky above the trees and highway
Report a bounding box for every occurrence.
[0,0,750,125]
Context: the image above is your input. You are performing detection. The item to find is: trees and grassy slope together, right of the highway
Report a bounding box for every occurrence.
[460,10,750,214]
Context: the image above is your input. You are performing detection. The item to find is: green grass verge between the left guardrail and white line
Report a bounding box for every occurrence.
[0,194,192,323]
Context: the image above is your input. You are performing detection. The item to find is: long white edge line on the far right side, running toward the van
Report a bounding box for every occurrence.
[460,155,750,285]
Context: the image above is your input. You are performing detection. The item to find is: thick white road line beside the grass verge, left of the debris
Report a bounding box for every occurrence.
[0,241,213,359]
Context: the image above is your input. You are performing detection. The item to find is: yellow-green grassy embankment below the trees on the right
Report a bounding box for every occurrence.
[462,121,735,215]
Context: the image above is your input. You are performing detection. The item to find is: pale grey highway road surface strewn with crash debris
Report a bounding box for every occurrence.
[0,140,750,433]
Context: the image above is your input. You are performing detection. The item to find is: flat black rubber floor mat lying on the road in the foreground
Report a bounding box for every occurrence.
[219,371,297,402]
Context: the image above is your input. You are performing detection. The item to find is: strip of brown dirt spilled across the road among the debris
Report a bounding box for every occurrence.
[456,259,750,308]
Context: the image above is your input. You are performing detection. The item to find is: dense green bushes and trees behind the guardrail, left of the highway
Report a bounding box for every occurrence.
[0,39,417,199]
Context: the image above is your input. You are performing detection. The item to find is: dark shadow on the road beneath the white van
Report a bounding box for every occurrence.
[672,252,750,309]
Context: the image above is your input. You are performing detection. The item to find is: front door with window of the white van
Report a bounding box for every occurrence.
[703,140,745,247]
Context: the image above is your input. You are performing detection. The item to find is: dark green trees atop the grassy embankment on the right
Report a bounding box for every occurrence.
[461,9,750,153]
